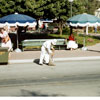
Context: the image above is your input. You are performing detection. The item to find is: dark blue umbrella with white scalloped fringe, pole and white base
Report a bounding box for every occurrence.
[0,13,36,52]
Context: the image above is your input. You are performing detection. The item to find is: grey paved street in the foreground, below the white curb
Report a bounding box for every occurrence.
[0,60,100,96]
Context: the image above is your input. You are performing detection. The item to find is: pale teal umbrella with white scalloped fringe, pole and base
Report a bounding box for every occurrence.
[67,13,100,50]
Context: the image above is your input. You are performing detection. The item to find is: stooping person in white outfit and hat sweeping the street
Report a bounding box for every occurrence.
[39,39,57,66]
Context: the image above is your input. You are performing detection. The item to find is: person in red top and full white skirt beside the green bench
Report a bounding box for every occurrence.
[67,34,78,50]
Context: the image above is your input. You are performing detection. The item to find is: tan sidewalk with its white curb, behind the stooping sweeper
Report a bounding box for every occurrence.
[9,43,100,63]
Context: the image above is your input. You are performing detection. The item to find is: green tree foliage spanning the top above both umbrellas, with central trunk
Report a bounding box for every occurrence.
[0,0,100,34]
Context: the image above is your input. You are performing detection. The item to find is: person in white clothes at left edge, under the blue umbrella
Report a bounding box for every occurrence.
[0,28,12,51]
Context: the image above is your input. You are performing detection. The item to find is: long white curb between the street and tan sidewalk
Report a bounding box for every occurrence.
[9,56,100,64]
